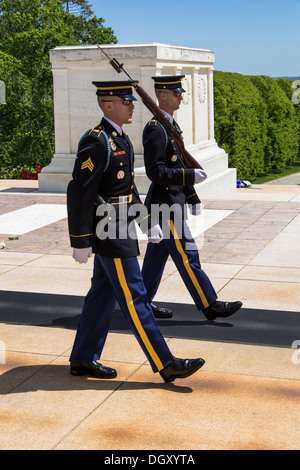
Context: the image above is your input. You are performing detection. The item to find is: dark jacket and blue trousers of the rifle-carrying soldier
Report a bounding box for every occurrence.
[142,119,217,310]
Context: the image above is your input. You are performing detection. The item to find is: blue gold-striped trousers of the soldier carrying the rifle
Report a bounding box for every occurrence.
[142,220,217,310]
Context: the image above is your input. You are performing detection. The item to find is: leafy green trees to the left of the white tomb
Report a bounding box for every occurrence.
[0,0,117,177]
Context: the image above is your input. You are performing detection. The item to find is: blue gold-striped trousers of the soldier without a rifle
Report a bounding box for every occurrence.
[70,254,174,372]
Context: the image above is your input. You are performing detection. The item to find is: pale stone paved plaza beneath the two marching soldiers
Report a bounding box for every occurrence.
[0,180,300,455]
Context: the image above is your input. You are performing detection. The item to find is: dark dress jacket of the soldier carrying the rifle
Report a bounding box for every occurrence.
[143,119,200,218]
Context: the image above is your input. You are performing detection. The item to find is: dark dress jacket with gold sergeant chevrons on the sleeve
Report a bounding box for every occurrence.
[67,118,148,258]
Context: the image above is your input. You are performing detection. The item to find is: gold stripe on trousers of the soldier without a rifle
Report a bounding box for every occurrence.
[114,258,164,371]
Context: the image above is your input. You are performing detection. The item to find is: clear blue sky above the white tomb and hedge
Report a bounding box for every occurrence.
[90,0,300,77]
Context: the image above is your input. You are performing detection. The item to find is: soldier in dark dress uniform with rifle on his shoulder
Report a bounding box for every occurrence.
[142,75,242,320]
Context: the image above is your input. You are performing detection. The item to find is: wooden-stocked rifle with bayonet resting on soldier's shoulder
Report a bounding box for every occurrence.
[97,45,203,170]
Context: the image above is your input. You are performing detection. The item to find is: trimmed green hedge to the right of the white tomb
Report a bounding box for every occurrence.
[214,71,300,179]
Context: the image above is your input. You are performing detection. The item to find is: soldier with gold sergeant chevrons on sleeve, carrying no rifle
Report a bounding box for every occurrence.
[67,81,204,382]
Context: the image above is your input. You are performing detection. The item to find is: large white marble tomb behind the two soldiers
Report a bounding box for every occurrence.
[39,44,236,194]
